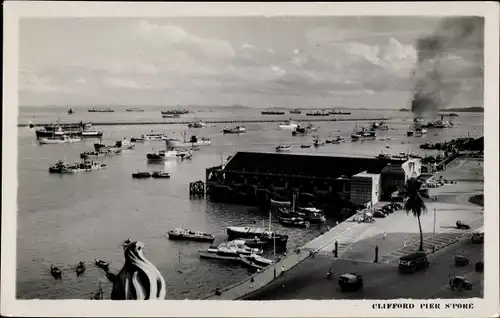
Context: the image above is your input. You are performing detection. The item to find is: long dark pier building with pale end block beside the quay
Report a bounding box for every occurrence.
[206,152,421,208]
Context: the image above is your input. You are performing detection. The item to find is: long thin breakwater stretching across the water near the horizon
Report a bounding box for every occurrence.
[17,118,390,127]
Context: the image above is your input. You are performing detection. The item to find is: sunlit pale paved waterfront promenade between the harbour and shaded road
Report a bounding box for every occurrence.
[204,158,484,300]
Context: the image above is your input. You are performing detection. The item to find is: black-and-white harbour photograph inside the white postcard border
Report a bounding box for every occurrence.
[4,3,495,314]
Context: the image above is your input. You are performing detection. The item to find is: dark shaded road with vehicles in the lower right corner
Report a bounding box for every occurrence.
[244,239,484,300]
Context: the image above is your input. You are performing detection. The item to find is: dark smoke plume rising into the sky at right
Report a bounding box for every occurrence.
[411,17,484,116]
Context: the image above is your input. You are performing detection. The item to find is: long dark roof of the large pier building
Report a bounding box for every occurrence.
[225,152,402,178]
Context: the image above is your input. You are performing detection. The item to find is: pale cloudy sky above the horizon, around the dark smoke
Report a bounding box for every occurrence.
[19,16,483,109]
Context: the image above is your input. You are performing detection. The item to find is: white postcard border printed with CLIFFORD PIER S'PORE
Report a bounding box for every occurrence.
[0,1,499,317]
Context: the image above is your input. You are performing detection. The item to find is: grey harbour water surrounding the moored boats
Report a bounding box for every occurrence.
[16,108,483,299]
